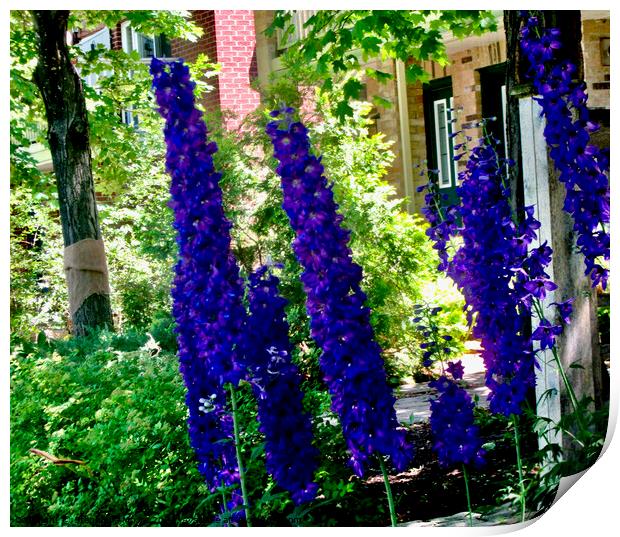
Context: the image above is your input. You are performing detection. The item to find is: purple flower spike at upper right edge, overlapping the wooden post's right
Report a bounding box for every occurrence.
[521,14,610,289]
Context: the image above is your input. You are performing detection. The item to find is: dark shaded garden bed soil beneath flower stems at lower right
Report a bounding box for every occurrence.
[270,423,544,526]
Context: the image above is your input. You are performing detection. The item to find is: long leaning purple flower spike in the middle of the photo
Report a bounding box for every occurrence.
[266,109,412,476]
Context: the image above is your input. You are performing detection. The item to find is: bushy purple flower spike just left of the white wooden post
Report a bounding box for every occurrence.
[427,137,561,416]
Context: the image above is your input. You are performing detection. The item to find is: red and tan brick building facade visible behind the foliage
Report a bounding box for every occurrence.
[49,10,610,213]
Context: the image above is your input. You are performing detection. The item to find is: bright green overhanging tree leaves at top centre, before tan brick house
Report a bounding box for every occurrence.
[266,10,497,118]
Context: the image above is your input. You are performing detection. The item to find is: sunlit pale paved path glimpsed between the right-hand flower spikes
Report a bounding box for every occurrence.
[394,350,489,424]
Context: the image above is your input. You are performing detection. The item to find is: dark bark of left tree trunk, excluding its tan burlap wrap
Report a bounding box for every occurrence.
[32,11,113,335]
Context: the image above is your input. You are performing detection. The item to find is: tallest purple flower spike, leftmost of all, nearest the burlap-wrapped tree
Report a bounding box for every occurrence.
[151,59,246,517]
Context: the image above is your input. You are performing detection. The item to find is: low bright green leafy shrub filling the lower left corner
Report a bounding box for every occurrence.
[11,333,218,526]
